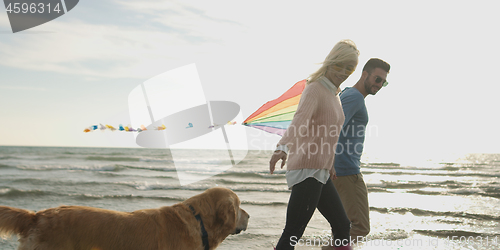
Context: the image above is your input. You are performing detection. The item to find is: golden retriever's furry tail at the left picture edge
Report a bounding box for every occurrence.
[0,206,36,237]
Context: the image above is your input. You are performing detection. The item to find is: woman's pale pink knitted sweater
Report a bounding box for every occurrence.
[278,79,345,172]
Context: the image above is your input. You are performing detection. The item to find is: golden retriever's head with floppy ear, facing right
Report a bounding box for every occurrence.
[185,187,250,238]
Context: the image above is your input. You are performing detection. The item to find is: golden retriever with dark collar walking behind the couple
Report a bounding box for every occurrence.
[0,187,250,250]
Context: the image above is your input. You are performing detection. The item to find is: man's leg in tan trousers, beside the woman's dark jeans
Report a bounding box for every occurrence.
[333,174,370,239]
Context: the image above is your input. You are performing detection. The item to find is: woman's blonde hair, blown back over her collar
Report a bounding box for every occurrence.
[307,39,359,84]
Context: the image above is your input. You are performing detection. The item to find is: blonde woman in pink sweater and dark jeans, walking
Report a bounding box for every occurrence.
[269,40,359,250]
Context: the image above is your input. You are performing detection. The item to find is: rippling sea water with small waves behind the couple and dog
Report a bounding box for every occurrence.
[0,147,500,250]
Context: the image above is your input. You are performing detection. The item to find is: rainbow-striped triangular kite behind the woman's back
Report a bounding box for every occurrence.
[243,80,306,136]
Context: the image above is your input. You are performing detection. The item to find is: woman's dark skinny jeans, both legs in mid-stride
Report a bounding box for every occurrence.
[276,177,351,250]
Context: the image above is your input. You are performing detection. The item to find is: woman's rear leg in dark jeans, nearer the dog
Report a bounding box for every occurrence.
[276,177,322,250]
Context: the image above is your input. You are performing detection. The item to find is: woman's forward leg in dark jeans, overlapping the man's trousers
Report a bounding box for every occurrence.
[317,179,351,246]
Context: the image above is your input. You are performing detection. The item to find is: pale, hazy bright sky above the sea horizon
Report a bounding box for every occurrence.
[0,0,500,163]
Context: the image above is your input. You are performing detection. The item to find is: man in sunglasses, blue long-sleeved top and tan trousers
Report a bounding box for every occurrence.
[333,58,390,244]
